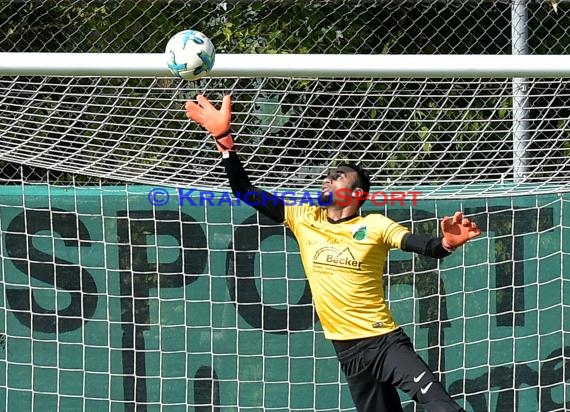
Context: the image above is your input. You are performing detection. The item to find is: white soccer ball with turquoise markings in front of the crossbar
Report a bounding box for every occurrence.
[165,30,216,80]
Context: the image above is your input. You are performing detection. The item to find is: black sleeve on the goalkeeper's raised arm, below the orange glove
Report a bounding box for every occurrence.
[222,152,285,223]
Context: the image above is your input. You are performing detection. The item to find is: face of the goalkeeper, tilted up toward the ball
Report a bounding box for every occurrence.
[319,166,359,209]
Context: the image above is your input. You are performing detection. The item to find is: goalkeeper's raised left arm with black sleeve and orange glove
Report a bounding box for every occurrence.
[186,95,285,223]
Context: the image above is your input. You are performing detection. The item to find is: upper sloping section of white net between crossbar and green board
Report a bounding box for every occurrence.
[0,77,570,197]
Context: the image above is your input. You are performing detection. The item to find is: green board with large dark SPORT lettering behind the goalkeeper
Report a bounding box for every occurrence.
[0,185,570,412]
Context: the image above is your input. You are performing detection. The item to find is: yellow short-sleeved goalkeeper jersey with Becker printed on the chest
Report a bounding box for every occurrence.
[285,204,409,340]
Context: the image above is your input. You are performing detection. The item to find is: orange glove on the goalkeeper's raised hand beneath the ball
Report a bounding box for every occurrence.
[186,94,234,153]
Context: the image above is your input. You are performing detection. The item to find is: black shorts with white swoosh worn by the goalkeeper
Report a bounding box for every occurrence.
[333,328,464,412]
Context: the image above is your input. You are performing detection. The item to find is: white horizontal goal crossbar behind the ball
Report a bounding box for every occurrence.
[0,53,570,78]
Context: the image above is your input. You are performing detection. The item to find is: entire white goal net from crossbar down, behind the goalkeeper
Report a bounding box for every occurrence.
[0,67,570,411]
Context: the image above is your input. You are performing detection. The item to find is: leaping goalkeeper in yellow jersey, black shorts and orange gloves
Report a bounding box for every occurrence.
[186,95,481,412]
